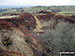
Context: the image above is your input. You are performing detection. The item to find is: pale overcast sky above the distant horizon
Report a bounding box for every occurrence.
[0,0,75,6]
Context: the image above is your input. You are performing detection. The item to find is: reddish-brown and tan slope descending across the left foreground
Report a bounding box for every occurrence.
[0,13,48,56]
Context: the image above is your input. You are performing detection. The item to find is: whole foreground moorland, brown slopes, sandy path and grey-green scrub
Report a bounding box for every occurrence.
[0,10,75,56]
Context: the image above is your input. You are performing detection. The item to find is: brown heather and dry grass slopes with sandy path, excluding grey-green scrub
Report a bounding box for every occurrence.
[0,11,75,56]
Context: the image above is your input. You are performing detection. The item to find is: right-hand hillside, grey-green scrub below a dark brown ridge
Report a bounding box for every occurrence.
[33,11,75,56]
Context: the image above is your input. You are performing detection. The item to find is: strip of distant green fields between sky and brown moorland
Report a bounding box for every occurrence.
[0,6,75,16]
